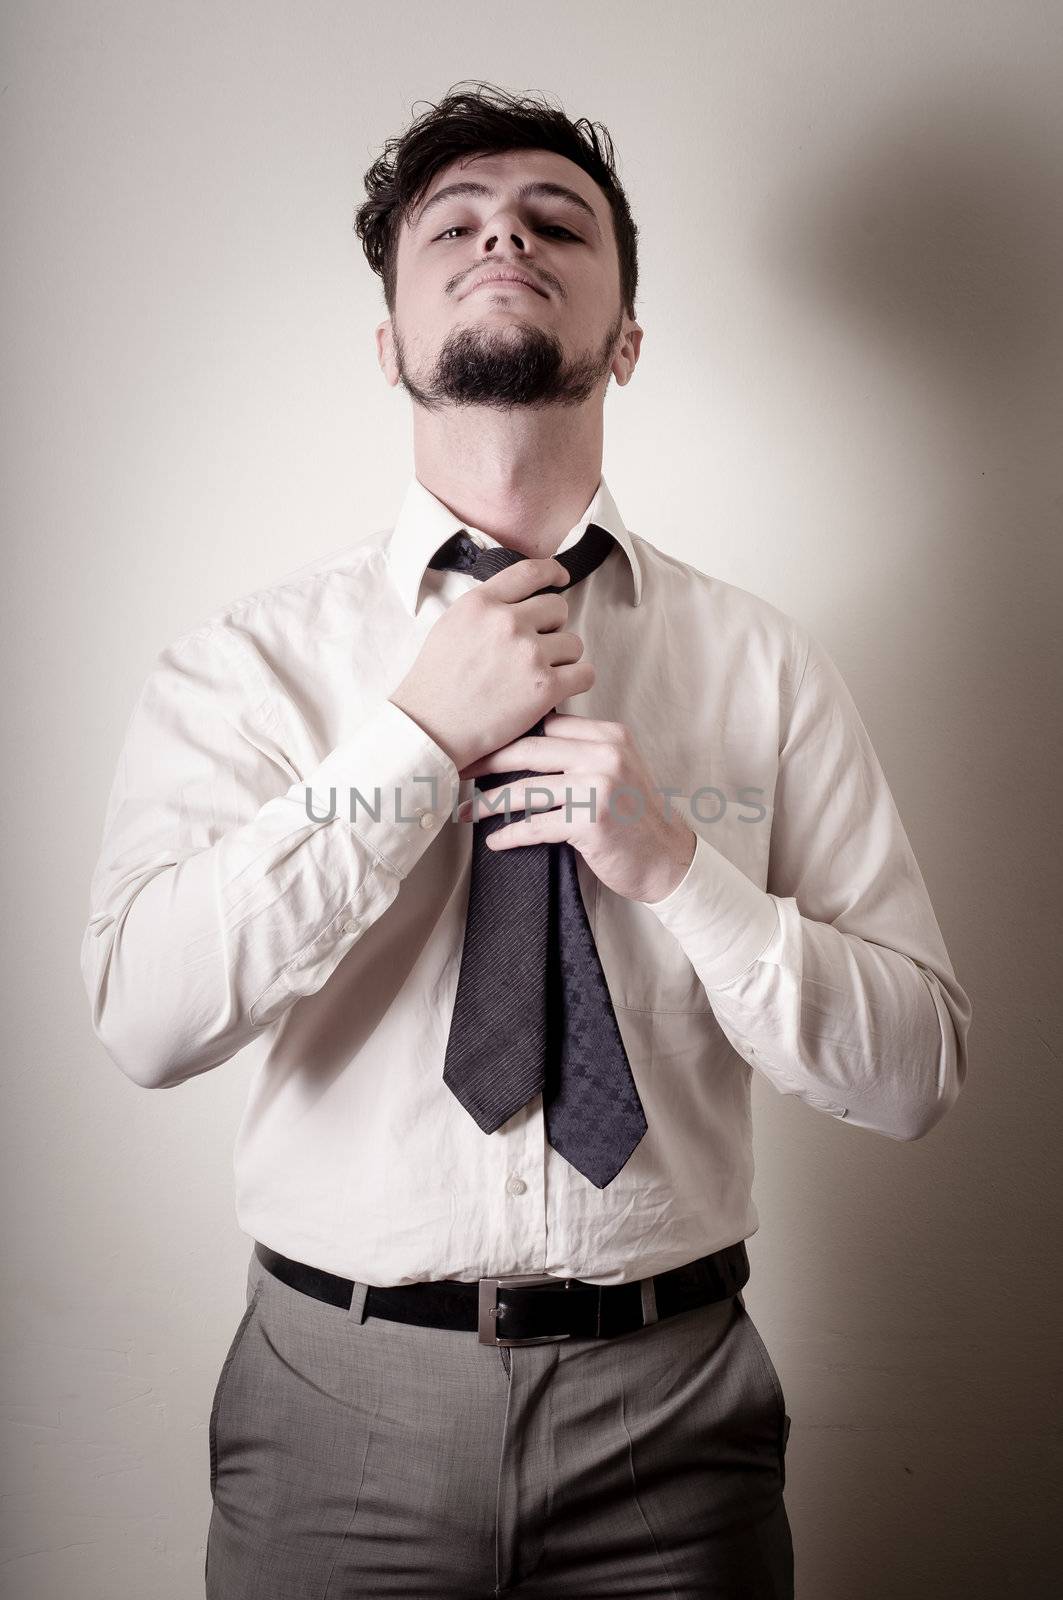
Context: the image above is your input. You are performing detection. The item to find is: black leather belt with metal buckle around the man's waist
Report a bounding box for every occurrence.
[255,1240,749,1344]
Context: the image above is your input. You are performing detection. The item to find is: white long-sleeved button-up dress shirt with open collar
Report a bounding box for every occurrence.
[82,478,970,1285]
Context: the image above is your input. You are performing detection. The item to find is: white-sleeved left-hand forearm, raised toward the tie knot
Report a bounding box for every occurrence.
[82,706,458,1088]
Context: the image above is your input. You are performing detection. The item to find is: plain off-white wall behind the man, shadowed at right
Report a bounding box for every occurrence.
[0,0,1063,1600]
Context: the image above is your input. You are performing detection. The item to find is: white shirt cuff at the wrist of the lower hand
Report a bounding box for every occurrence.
[642,834,780,989]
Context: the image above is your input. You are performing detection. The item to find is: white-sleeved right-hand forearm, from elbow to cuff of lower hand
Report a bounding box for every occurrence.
[652,838,970,1139]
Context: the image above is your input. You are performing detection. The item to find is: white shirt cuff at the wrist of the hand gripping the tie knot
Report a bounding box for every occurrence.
[304,699,461,878]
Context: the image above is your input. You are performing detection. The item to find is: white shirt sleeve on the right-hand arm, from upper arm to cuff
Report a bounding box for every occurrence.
[650,635,970,1139]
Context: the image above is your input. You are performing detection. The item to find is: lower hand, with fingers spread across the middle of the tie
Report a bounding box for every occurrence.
[456,712,696,901]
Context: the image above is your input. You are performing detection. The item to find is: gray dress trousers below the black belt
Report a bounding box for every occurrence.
[207,1254,794,1600]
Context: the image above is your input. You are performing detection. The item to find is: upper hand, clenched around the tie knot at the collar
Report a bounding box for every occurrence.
[387,555,594,771]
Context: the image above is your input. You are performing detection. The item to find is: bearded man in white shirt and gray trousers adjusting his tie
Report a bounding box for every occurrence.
[83,86,970,1600]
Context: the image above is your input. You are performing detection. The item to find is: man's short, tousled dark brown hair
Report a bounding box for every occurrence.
[354,83,639,317]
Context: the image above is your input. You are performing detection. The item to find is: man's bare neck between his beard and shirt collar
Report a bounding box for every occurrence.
[413,395,602,555]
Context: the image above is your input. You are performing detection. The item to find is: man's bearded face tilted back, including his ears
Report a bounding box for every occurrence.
[378,150,642,405]
